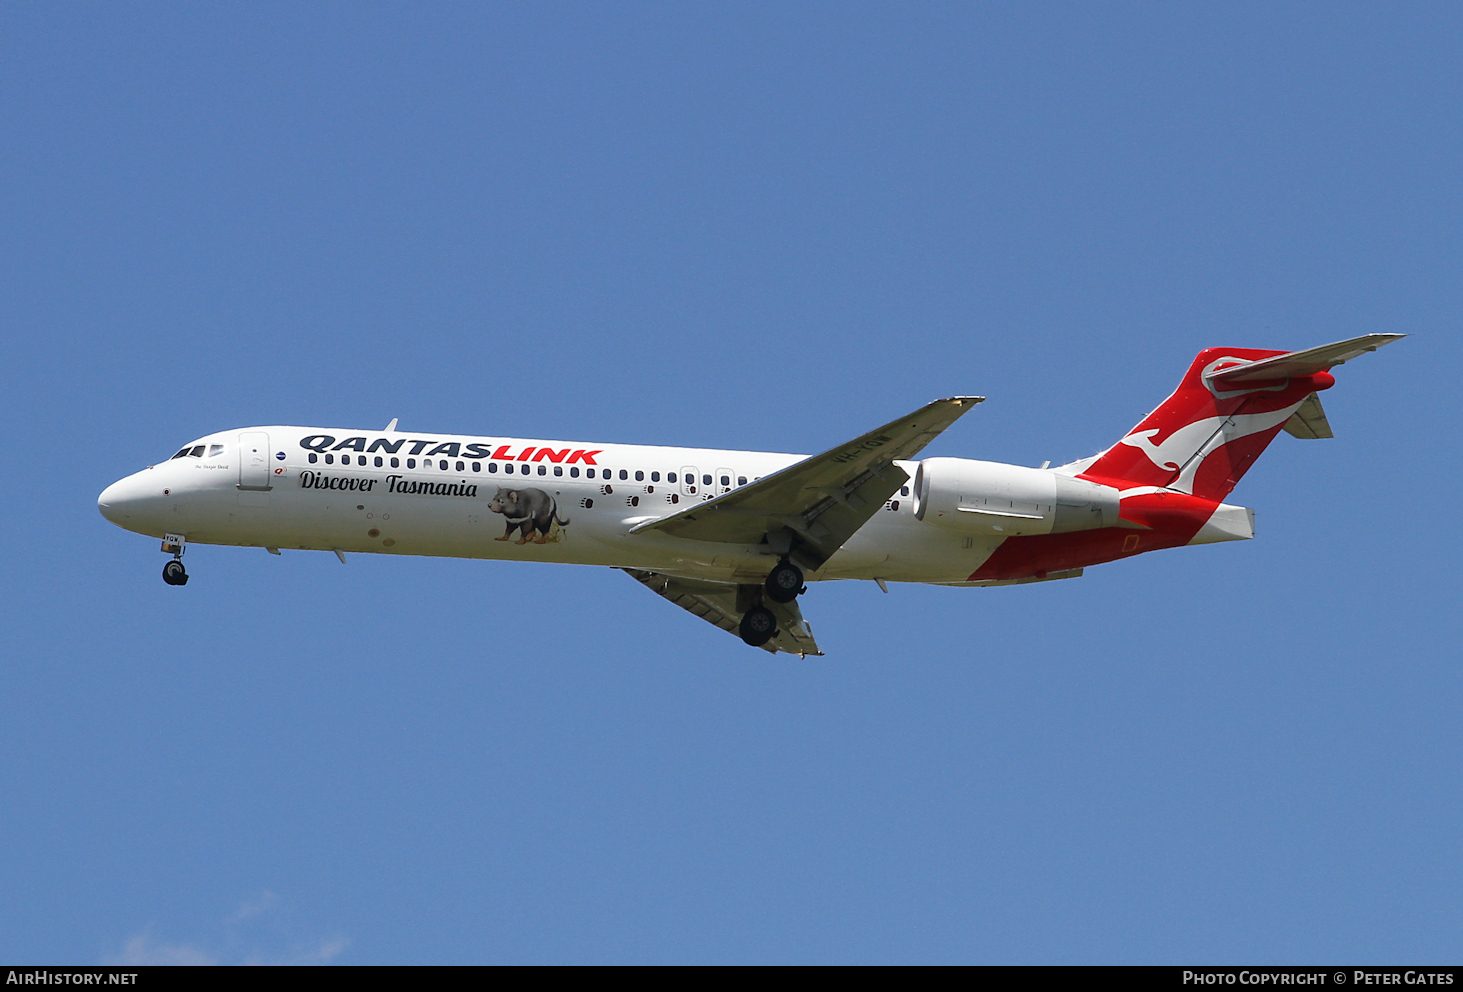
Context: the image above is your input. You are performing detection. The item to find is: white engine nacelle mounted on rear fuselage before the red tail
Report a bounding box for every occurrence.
[914,458,1119,537]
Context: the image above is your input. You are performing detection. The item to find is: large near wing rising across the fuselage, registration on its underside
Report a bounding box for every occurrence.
[631,397,985,569]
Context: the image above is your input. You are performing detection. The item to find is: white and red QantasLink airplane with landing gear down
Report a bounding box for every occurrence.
[97,334,1404,657]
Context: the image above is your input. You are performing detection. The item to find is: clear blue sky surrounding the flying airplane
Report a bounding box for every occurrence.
[0,3,1463,964]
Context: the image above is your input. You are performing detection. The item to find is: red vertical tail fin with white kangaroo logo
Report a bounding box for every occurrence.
[1080,348,1336,500]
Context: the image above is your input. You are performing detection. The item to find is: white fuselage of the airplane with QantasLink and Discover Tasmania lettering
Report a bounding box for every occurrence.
[98,427,1037,582]
